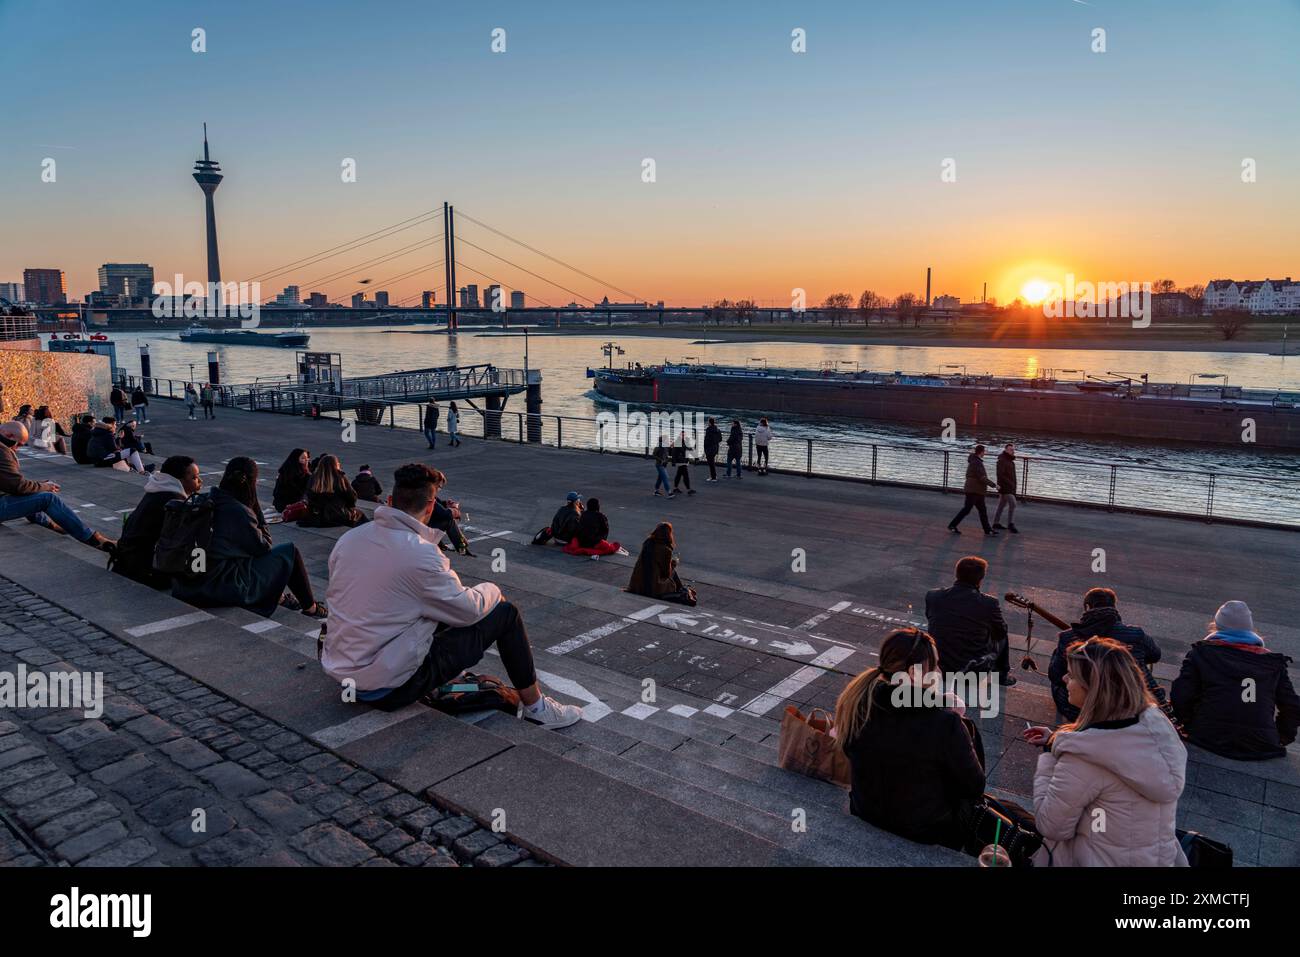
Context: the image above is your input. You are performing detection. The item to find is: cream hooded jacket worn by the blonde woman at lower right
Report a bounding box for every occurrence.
[1034,707,1187,867]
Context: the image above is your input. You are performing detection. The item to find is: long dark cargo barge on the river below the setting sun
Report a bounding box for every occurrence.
[588,364,1300,449]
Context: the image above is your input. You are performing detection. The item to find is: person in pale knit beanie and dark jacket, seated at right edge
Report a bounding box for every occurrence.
[1170,602,1300,761]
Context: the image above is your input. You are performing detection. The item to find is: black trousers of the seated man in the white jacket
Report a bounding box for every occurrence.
[371,601,537,711]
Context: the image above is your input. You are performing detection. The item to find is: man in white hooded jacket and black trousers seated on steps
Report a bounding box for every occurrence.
[321,464,582,728]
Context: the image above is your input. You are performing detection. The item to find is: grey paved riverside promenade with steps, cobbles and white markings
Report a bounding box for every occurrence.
[0,399,1300,866]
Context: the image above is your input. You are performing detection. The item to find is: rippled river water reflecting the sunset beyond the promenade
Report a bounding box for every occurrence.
[113,326,1300,524]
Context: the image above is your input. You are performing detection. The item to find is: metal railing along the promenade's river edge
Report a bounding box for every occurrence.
[129,380,1300,529]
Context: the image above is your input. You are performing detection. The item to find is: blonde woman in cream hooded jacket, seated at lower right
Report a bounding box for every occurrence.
[1023,638,1187,867]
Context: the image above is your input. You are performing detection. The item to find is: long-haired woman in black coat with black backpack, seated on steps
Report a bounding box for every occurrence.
[172,455,326,619]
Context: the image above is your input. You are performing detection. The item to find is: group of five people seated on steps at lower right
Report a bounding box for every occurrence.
[833,557,1300,866]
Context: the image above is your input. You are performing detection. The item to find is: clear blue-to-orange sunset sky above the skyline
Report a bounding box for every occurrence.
[0,0,1300,307]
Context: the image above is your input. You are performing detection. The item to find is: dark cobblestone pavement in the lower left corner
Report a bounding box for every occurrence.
[0,577,540,867]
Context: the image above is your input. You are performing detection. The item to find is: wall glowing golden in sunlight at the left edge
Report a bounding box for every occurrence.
[0,342,113,423]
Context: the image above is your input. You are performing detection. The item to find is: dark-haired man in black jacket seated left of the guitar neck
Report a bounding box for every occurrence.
[926,555,1015,687]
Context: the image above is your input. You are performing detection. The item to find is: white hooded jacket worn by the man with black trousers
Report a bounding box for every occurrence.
[321,506,501,692]
